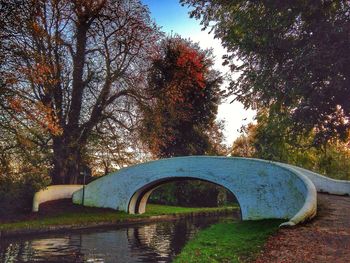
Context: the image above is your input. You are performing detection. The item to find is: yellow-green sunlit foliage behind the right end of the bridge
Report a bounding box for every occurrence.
[232,110,350,180]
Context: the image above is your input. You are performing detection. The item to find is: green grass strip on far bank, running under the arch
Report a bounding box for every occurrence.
[0,204,235,231]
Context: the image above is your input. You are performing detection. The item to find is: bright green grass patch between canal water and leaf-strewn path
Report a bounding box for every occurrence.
[174,220,282,263]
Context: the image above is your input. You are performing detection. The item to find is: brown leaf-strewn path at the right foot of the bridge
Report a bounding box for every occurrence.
[256,194,350,263]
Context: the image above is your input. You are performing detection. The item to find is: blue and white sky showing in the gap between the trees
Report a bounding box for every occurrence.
[142,0,255,145]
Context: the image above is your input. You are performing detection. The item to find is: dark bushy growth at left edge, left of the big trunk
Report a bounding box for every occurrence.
[0,106,51,218]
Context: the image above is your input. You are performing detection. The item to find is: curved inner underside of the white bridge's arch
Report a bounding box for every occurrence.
[128,177,240,217]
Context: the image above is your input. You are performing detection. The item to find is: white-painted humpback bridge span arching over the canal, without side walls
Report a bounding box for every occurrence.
[73,156,316,225]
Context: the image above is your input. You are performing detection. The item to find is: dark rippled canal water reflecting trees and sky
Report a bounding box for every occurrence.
[0,216,238,263]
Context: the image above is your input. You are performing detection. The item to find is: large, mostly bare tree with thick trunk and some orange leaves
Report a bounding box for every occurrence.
[0,0,159,184]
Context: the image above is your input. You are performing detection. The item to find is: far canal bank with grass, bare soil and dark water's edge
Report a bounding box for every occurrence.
[0,201,240,239]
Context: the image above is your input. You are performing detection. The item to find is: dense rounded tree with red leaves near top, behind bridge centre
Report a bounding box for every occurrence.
[141,37,222,158]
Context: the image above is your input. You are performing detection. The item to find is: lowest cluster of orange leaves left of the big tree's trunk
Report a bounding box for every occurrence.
[8,97,63,136]
